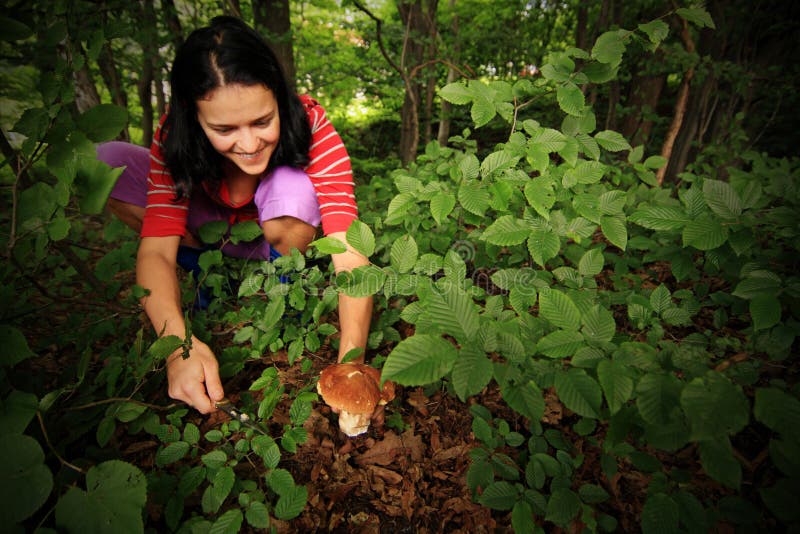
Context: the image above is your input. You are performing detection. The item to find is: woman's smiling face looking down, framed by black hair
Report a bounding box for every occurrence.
[197,84,281,176]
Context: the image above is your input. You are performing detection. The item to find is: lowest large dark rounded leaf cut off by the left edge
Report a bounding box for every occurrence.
[0,438,53,527]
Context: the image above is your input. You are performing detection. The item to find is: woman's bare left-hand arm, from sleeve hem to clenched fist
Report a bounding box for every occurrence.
[136,236,224,413]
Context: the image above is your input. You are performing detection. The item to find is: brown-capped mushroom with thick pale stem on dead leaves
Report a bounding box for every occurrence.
[317,363,394,437]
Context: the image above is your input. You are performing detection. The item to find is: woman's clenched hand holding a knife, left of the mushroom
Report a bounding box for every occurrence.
[167,337,225,413]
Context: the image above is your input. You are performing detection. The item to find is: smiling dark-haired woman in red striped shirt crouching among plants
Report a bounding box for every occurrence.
[98,17,372,413]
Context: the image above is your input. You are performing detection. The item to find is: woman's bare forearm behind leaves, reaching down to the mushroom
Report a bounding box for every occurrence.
[330,232,373,362]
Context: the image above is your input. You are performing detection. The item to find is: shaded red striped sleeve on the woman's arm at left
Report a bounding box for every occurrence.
[141,115,189,237]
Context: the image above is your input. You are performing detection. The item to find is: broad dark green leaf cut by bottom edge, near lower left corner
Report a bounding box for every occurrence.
[56,460,147,534]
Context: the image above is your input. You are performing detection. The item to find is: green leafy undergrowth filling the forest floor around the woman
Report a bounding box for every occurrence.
[0,6,800,532]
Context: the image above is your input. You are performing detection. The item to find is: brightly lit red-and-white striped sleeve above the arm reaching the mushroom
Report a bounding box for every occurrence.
[300,96,358,235]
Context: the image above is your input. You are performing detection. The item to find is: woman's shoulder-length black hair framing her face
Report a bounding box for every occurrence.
[161,16,311,198]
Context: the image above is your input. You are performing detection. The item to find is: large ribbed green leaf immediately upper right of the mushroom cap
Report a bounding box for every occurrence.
[381,334,458,386]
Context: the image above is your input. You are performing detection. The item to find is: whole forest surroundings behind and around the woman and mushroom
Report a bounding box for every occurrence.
[0,0,800,532]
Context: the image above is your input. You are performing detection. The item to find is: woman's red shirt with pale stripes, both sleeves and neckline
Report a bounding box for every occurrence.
[141,95,358,237]
